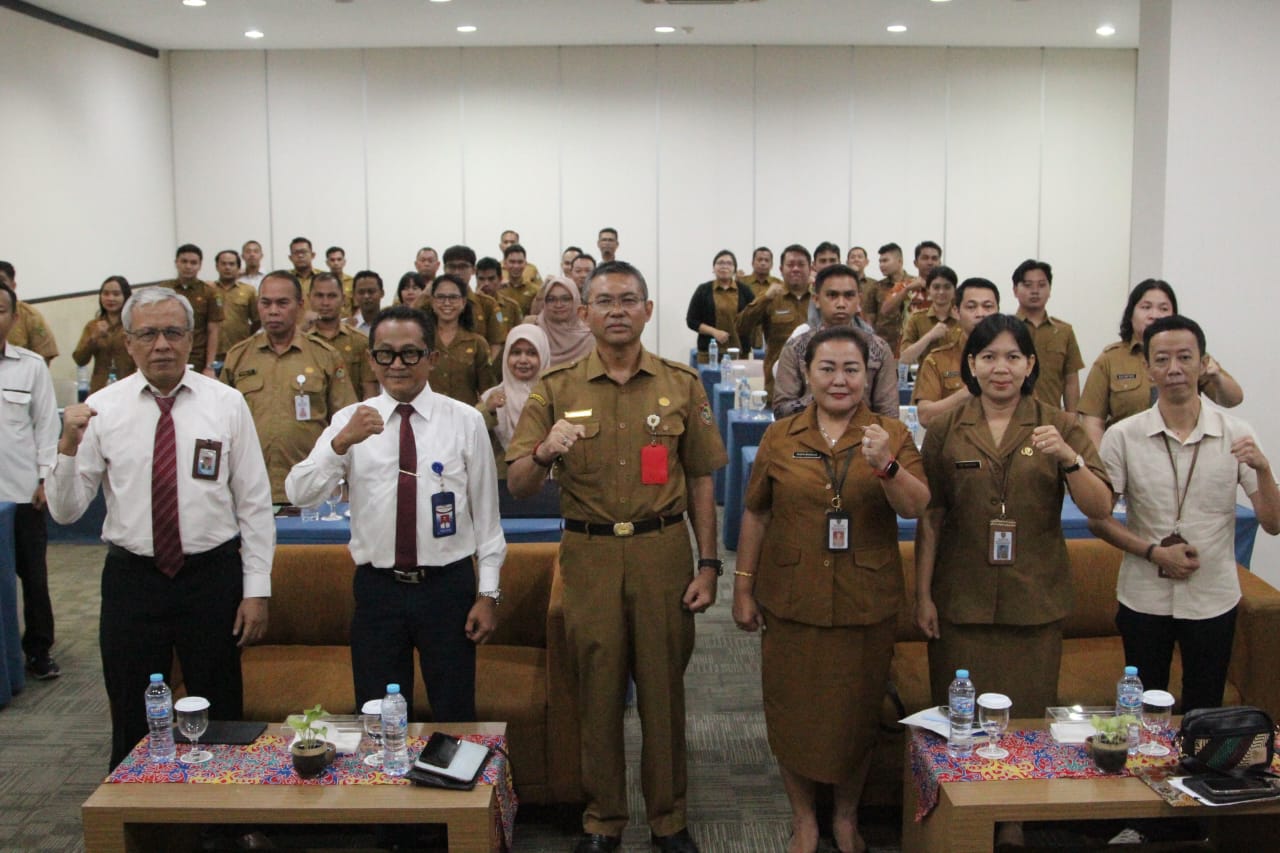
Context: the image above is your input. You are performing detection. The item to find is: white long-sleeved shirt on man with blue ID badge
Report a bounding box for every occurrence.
[284,386,507,592]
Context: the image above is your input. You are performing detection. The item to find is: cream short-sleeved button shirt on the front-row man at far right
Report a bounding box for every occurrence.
[1098,396,1258,619]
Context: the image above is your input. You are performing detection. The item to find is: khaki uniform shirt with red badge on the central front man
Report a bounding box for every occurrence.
[507,350,728,523]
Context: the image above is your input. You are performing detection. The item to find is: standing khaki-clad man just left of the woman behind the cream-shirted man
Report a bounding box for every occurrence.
[1014,259,1084,411]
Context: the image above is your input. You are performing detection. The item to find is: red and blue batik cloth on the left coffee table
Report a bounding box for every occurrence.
[106,734,518,850]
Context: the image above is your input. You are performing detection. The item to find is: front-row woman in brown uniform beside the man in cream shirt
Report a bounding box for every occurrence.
[915,314,1112,717]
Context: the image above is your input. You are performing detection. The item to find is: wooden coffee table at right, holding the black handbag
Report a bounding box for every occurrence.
[902,720,1280,853]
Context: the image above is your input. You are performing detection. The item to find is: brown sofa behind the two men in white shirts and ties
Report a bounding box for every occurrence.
[242,543,582,803]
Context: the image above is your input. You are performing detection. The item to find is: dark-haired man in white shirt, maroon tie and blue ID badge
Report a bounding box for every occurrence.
[284,306,507,722]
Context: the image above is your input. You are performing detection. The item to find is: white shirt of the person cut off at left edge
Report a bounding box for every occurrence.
[0,343,60,503]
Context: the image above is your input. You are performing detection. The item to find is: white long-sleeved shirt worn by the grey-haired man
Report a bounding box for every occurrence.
[45,370,275,598]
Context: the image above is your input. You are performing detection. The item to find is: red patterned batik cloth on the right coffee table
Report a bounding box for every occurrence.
[910,727,1175,821]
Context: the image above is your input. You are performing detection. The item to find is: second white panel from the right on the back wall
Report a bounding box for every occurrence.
[947,49,1057,281]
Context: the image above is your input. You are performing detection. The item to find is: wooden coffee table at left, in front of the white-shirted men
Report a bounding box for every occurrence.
[81,722,507,853]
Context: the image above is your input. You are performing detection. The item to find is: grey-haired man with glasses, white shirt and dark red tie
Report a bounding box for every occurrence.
[45,287,275,767]
